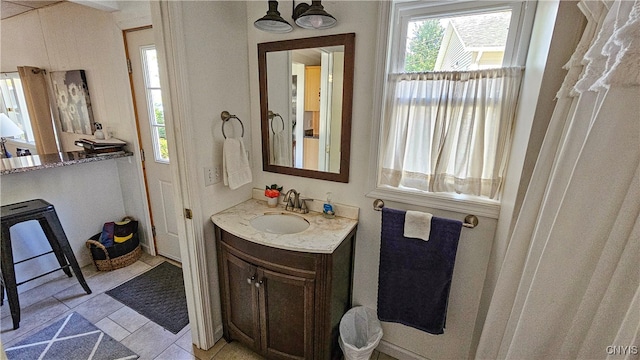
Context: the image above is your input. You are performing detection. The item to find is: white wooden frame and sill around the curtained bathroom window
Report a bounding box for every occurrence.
[367,1,537,219]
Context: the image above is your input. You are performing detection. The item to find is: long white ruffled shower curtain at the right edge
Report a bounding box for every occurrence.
[476,0,640,359]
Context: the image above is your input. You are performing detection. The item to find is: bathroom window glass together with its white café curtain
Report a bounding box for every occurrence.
[378,0,533,200]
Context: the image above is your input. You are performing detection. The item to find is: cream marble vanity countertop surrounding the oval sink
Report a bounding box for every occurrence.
[211,199,358,254]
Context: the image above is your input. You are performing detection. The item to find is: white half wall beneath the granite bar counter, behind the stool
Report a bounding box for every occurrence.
[0,160,126,292]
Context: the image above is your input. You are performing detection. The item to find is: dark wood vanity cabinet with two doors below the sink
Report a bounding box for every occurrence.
[215,226,356,359]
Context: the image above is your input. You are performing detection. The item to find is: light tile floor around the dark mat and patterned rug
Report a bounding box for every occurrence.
[0,254,393,360]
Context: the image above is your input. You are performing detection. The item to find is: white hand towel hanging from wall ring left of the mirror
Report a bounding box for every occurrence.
[222,138,252,190]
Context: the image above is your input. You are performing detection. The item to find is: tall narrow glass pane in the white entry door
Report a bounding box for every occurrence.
[141,45,169,163]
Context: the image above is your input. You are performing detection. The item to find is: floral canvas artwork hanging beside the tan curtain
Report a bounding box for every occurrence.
[51,70,94,135]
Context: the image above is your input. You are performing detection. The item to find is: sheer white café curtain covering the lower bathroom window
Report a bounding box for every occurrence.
[379,67,523,199]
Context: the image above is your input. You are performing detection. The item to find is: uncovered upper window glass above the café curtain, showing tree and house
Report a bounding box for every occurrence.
[404,10,511,72]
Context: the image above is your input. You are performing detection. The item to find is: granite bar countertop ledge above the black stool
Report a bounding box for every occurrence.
[0,151,133,175]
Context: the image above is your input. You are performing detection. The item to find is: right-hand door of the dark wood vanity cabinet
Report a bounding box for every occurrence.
[258,268,315,359]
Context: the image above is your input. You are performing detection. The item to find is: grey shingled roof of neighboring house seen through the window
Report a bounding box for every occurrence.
[451,11,511,48]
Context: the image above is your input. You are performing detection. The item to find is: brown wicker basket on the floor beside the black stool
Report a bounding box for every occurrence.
[86,233,142,271]
